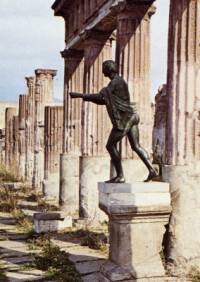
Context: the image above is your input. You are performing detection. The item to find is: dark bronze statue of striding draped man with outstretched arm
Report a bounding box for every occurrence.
[70,60,157,183]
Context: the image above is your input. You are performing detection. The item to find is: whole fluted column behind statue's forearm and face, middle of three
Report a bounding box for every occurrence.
[80,33,112,223]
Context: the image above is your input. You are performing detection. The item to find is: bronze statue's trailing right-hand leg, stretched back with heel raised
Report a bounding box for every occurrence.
[127,125,157,181]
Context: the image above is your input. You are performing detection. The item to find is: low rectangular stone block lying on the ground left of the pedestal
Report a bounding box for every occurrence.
[34,212,72,233]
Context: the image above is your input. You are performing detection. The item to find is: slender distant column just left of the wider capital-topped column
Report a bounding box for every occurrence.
[25,76,35,183]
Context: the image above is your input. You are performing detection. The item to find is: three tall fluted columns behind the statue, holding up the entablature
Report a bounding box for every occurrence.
[60,1,155,218]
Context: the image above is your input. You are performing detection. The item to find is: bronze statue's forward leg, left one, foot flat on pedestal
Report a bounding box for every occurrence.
[106,128,125,183]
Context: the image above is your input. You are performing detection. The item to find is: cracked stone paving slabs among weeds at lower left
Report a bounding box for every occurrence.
[0,184,106,282]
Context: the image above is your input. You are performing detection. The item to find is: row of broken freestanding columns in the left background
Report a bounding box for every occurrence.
[5,69,63,196]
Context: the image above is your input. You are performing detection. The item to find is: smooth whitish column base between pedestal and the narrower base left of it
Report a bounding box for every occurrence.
[80,157,110,223]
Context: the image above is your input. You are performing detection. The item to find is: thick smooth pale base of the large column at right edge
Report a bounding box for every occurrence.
[162,163,200,276]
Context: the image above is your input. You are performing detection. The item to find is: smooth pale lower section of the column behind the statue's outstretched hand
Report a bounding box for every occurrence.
[59,153,79,218]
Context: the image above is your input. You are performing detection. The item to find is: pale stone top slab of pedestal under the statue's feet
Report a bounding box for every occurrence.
[98,182,171,214]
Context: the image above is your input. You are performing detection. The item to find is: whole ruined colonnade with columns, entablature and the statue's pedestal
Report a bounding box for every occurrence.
[0,0,200,282]
